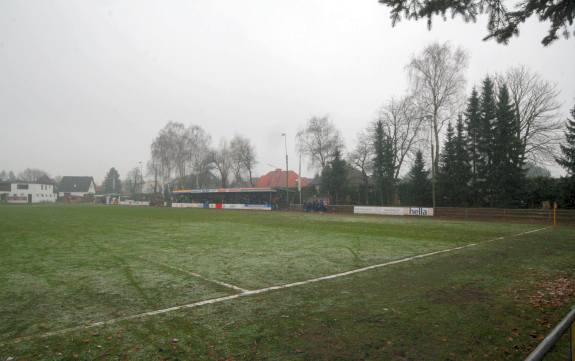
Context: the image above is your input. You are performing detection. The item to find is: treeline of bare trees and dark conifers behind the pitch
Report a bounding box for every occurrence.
[4,43,575,208]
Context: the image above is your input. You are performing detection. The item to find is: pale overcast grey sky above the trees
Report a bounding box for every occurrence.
[0,0,575,181]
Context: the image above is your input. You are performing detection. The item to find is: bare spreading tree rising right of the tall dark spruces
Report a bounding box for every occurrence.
[497,65,563,162]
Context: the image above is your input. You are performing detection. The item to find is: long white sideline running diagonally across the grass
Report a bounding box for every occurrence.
[5,226,551,345]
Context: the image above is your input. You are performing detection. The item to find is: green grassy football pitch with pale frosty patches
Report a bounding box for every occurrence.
[0,205,575,360]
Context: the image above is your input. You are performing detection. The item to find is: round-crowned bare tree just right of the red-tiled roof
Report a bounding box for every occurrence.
[297,116,343,172]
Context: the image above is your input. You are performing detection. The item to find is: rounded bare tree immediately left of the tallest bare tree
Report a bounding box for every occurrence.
[379,96,425,181]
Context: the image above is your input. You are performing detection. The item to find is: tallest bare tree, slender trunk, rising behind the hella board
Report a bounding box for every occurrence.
[407,43,468,207]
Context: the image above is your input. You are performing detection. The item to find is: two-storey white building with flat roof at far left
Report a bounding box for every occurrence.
[0,181,58,203]
